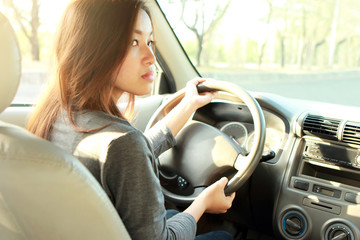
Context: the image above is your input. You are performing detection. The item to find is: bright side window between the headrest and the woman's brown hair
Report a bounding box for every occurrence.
[0,0,69,105]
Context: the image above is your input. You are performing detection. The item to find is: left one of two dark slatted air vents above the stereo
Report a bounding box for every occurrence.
[303,114,341,140]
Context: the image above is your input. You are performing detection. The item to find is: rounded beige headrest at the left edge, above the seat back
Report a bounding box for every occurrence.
[0,13,21,112]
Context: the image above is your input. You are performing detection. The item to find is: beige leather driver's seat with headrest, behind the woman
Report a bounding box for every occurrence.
[0,13,130,240]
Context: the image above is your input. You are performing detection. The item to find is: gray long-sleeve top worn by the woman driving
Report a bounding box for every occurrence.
[50,111,196,240]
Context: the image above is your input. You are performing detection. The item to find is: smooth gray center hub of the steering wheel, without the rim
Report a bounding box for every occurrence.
[159,121,240,187]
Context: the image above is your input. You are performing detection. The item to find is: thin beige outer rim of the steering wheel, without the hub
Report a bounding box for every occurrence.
[146,81,266,204]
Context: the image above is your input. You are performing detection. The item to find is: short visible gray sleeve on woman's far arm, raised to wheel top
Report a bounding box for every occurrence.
[144,122,176,158]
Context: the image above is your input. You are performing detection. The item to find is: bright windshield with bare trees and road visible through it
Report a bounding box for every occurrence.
[158,0,360,106]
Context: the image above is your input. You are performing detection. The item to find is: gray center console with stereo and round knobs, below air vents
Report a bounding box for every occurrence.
[274,136,360,240]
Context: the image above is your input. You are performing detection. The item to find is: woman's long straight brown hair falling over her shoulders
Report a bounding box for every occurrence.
[27,0,150,139]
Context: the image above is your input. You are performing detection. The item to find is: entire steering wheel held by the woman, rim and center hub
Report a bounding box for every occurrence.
[146,81,266,204]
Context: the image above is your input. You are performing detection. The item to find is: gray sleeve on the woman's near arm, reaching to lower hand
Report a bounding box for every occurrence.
[103,131,196,240]
